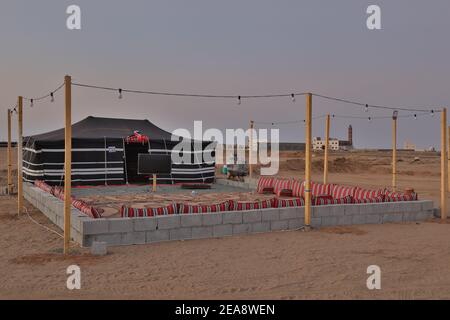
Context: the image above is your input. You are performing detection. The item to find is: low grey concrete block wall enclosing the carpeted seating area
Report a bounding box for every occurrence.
[24,185,434,247]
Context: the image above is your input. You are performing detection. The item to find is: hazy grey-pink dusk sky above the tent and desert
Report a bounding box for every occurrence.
[0,0,450,148]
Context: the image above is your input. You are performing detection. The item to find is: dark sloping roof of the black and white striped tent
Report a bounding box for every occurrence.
[26,116,179,141]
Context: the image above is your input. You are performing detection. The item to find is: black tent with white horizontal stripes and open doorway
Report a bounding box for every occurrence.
[23,117,215,185]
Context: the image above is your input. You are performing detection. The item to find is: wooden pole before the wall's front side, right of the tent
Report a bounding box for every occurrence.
[305,93,312,227]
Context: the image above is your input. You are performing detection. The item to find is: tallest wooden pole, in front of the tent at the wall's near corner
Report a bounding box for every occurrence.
[64,76,72,255]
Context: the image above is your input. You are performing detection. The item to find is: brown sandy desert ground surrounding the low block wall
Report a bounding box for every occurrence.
[0,150,450,299]
